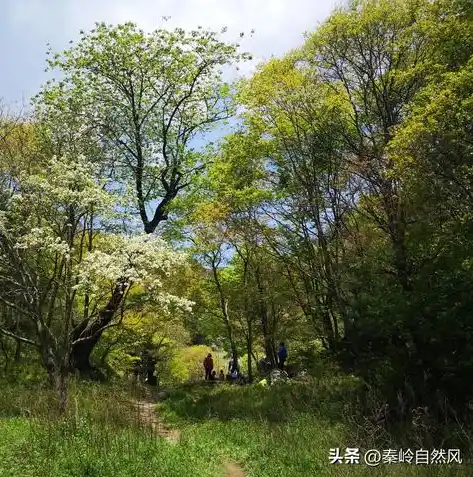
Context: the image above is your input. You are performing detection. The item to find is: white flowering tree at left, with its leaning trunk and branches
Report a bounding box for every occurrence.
[0,157,189,408]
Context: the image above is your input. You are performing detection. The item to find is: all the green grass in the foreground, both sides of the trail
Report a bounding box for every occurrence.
[0,376,473,477]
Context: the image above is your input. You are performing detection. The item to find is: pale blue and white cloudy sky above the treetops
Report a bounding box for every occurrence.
[0,0,340,109]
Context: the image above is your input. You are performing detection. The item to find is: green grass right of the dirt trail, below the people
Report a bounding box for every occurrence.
[159,378,473,477]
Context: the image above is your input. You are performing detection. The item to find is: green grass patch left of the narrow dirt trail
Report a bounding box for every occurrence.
[0,383,221,477]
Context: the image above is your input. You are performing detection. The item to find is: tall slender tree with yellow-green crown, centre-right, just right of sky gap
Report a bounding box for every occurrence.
[241,53,354,349]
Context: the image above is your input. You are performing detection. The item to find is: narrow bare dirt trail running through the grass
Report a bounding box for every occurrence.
[132,386,246,477]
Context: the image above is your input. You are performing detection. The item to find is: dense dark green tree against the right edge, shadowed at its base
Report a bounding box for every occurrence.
[380,59,473,412]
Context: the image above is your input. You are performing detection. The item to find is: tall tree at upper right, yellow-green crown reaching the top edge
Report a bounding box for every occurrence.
[298,0,438,293]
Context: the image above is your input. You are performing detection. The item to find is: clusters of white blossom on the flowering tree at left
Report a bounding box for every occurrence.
[0,152,192,320]
